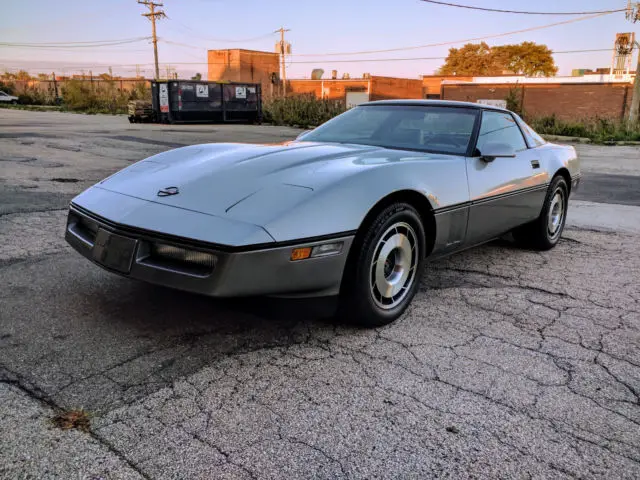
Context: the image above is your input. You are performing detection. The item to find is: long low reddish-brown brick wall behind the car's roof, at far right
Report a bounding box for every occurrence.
[443,83,632,120]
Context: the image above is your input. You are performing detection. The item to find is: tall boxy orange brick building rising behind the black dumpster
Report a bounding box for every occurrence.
[207,48,280,95]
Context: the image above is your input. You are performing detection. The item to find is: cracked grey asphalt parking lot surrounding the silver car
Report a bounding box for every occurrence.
[0,110,640,479]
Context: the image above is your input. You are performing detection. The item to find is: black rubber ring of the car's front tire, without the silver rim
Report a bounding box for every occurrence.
[347,203,426,326]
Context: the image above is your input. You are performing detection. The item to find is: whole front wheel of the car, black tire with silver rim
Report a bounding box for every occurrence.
[338,203,426,327]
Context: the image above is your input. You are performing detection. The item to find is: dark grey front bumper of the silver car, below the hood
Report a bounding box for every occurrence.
[65,206,353,297]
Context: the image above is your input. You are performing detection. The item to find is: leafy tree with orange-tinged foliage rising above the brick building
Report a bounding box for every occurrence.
[438,42,558,77]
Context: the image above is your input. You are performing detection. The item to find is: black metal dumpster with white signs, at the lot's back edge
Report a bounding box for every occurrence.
[151,80,262,123]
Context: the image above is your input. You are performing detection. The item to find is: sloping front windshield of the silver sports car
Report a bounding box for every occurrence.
[301,105,478,155]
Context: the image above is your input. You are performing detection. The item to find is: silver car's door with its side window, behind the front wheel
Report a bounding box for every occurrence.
[467,110,548,243]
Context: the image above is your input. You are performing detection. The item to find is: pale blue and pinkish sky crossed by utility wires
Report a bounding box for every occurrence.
[0,0,640,78]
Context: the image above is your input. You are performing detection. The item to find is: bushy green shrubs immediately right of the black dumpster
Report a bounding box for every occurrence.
[262,95,346,128]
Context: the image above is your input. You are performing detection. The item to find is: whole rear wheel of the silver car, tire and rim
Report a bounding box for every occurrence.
[513,176,569,251]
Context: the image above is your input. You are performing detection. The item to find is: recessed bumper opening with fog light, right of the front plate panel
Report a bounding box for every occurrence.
[141,243,217,277]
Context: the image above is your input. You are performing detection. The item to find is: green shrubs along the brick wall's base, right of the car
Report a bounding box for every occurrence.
[527,115,640,144]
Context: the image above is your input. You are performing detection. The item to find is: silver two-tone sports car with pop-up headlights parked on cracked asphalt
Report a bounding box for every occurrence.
[66,100,580,326]
